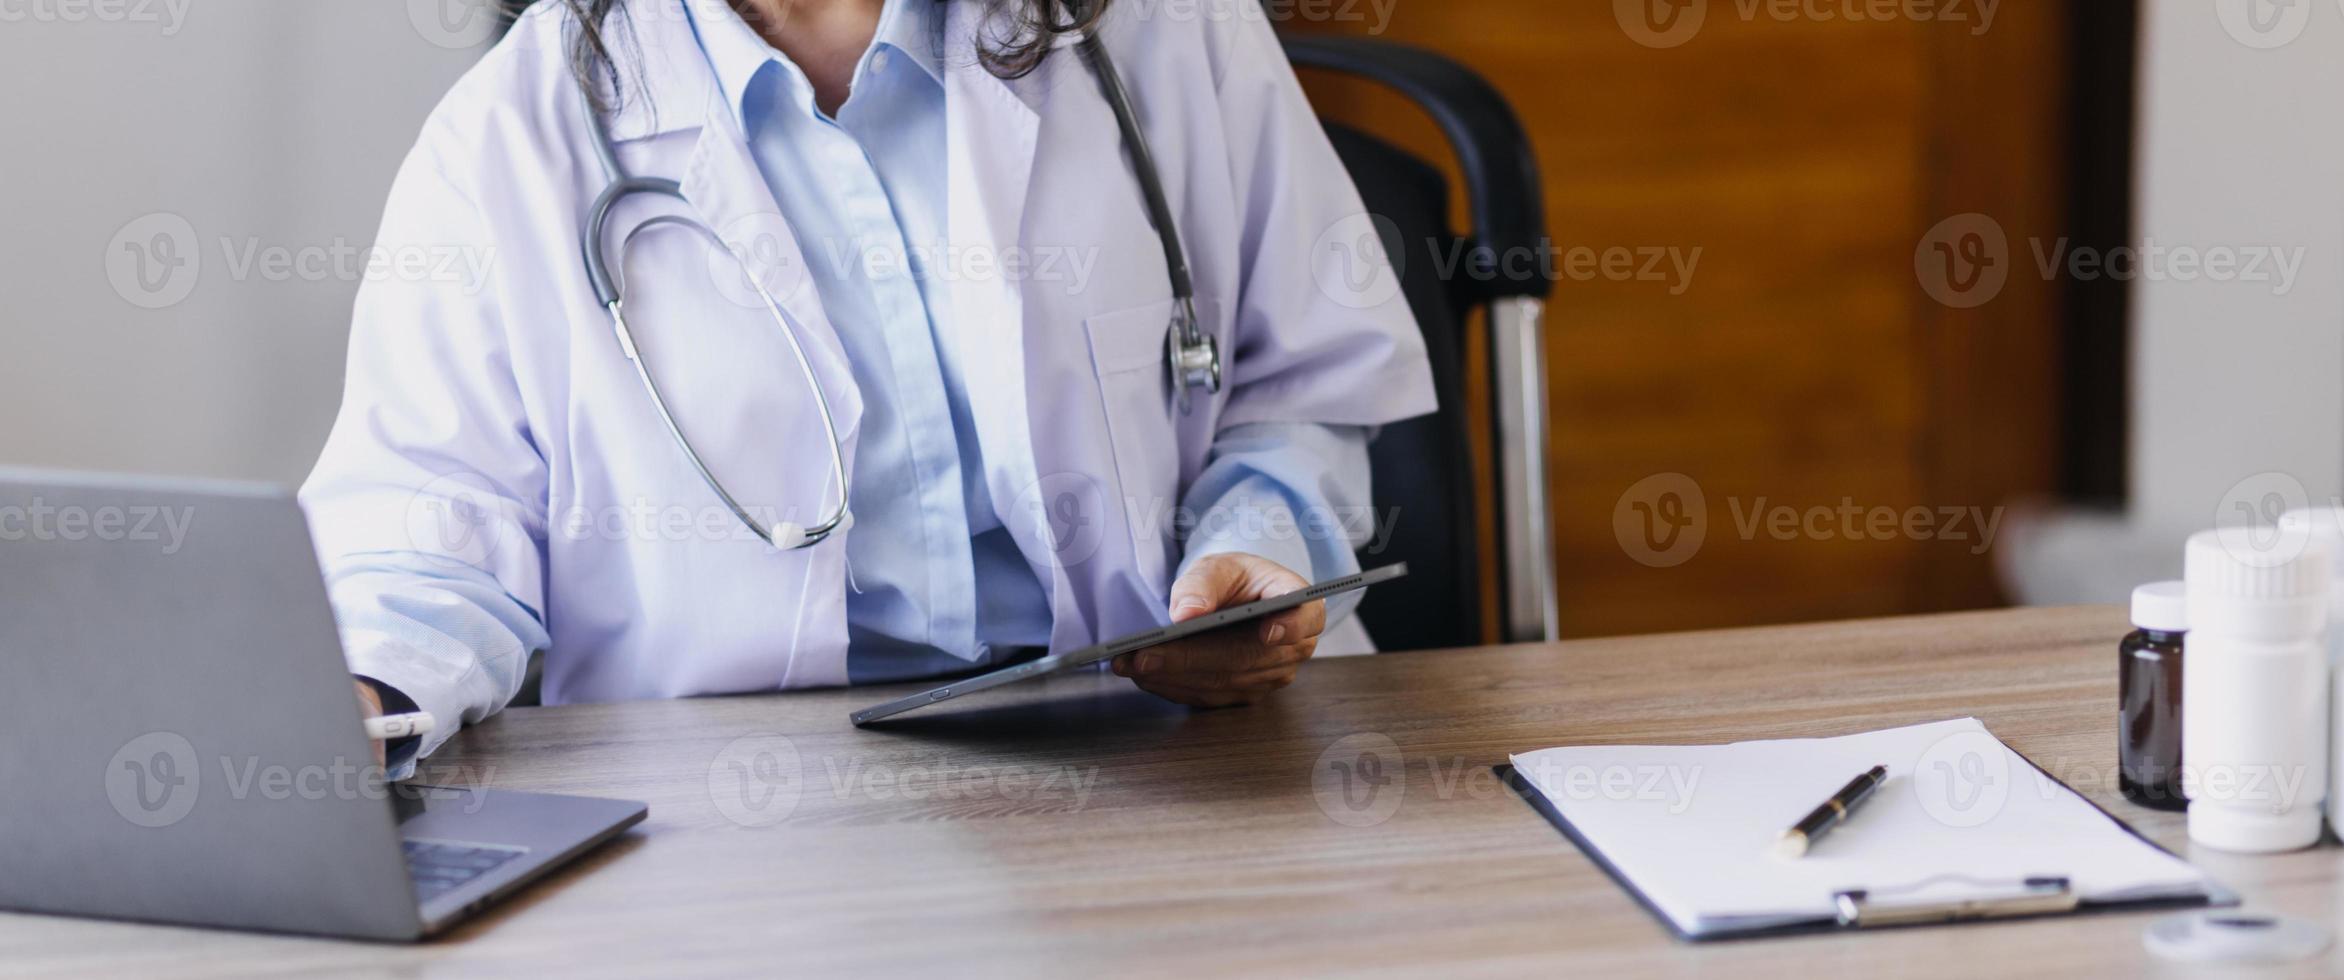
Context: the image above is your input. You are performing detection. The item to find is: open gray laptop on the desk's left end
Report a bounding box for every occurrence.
[0,469,647,940]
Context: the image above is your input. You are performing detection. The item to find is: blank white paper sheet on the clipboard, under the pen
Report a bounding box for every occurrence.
[1514,717,2210,935]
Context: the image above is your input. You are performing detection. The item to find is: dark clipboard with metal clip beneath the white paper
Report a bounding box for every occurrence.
[1495,727,2239,942]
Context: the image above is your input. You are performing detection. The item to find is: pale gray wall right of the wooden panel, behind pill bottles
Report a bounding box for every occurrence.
[1997,0,2344,605]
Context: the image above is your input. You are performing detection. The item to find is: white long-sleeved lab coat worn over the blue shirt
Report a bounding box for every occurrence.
[302,0,1432,717]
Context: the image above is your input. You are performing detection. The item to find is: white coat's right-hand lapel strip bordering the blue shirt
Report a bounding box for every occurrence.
[942,2,1090,649]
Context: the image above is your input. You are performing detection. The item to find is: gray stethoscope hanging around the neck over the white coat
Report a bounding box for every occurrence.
[579,35,1221,551]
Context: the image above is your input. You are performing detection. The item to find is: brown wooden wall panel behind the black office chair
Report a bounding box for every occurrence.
[1287,0,2067,635]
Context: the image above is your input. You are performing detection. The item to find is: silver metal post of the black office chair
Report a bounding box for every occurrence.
[1488,295,1563,642]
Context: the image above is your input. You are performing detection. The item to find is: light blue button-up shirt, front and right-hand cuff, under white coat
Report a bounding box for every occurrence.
[687,0,1367,682]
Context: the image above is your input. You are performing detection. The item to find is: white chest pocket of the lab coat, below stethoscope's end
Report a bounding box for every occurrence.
[1083,298,1179,596]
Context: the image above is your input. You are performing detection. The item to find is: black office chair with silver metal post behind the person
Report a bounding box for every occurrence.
[1285,35,1559,649]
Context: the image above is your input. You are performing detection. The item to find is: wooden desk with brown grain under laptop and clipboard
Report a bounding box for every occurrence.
[0,607,2344,980]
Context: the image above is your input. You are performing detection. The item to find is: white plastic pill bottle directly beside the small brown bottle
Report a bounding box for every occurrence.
[2182,528,2330,853]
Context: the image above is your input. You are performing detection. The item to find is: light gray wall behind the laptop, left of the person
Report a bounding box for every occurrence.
[0,0,492,483]
